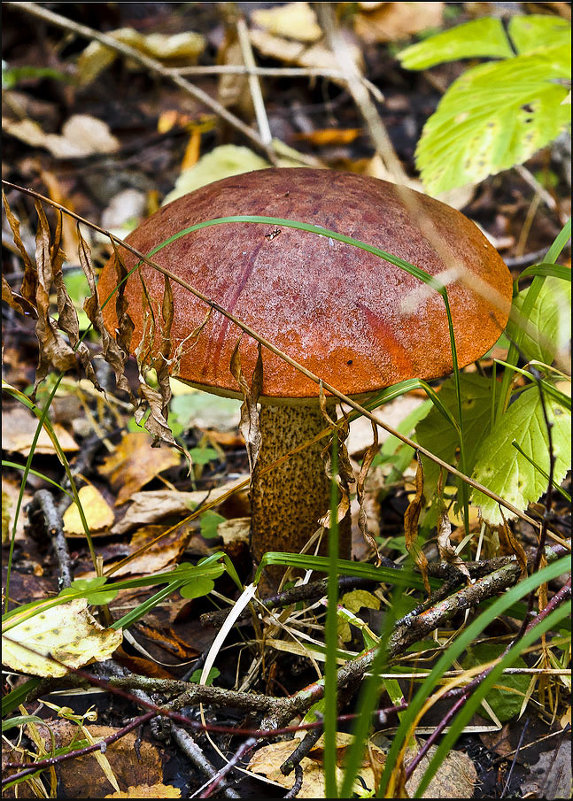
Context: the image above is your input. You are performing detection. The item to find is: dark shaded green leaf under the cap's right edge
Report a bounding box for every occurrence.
[416,373,492,516]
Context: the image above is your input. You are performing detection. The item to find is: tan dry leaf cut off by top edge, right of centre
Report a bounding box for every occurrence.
[354,3,445,44]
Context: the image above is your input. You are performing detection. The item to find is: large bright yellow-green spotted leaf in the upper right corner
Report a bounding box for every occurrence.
[416,46,571,194]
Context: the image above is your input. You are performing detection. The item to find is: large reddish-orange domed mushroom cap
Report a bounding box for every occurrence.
[99,168,512,402]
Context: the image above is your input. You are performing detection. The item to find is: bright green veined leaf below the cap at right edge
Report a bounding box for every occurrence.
[472,386,571,525]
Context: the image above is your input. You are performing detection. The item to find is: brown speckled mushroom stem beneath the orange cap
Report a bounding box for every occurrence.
[251,402,350,580]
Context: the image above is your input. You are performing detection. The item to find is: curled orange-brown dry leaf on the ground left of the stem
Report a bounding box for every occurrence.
[99,431,181,506]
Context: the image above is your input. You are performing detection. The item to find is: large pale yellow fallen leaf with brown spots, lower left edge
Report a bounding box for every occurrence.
[2,598,123,677]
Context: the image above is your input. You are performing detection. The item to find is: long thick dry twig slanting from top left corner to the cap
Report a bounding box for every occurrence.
[4,2,276,162]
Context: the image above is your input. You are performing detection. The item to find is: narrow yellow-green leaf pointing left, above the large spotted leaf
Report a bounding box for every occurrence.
[398,17,514,70]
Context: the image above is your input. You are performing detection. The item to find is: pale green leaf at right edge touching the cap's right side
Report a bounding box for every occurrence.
[508,276,571,364]
